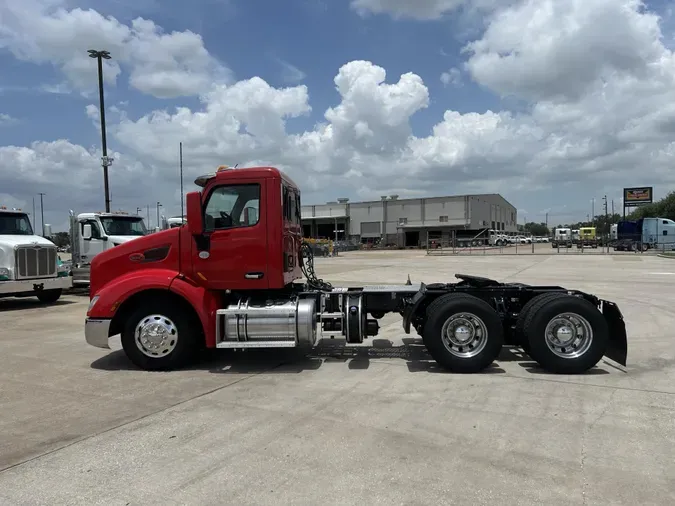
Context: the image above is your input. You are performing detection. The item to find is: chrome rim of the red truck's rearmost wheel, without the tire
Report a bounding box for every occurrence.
[545,313,593,359]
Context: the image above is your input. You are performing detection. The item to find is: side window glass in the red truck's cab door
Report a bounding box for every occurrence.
[204,184,260,230]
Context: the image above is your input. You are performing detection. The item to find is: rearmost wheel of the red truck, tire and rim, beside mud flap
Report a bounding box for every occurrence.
[523,294,609,374]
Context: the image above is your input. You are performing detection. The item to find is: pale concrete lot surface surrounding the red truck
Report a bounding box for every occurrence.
[0,251,675,506]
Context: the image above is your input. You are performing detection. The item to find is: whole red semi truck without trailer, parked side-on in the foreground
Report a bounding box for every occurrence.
[85,167,627,373]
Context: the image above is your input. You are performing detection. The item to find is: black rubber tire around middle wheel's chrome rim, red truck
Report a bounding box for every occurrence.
[422,293,504,373]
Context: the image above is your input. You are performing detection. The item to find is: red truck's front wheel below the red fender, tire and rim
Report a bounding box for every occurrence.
[122,302,199,371]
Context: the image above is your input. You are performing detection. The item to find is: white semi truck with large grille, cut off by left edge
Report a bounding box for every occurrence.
[0,206,72,303]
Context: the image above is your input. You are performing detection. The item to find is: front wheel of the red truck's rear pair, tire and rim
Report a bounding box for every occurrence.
[422,294,504,373]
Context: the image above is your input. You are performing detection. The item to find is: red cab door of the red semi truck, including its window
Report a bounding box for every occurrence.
[193,180,269,290]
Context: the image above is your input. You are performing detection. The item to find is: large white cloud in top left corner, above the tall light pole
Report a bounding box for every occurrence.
[0,0,231,98]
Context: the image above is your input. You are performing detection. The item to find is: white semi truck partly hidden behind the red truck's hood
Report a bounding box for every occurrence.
[70,211,148,287]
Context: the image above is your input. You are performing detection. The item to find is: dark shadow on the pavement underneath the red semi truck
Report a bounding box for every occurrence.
[91,338,609,375]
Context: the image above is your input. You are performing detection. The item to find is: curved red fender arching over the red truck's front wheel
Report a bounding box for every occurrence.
[87,269,178,319]
